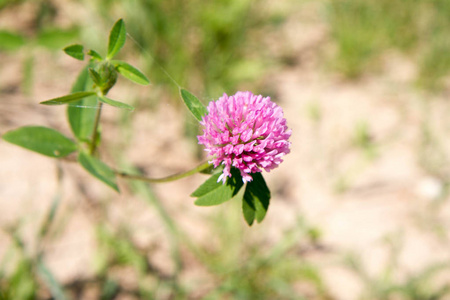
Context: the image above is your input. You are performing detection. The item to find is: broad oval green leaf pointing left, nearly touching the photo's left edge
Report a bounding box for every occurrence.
[2,126,77,157]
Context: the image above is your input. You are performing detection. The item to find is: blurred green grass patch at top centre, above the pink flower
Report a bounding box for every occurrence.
[86,0,273,96]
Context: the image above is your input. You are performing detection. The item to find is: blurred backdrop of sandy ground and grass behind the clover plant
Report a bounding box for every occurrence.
[0,0,450,300]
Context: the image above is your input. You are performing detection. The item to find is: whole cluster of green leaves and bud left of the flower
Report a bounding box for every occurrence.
[2,19,150,191]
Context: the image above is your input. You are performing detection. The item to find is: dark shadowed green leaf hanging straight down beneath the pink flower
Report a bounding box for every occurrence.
[242,173,270,226]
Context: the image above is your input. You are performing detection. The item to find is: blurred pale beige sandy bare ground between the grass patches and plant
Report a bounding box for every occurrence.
[0,1,450,300]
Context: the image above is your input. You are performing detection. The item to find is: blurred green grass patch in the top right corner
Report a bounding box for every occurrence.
[327,0,450,90]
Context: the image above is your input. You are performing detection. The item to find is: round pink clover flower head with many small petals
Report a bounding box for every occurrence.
[197,92,292,182]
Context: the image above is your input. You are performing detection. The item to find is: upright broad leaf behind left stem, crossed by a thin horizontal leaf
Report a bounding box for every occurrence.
[67,65,97,141]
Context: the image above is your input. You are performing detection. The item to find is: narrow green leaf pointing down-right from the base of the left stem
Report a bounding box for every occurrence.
[78,152,119,191]
